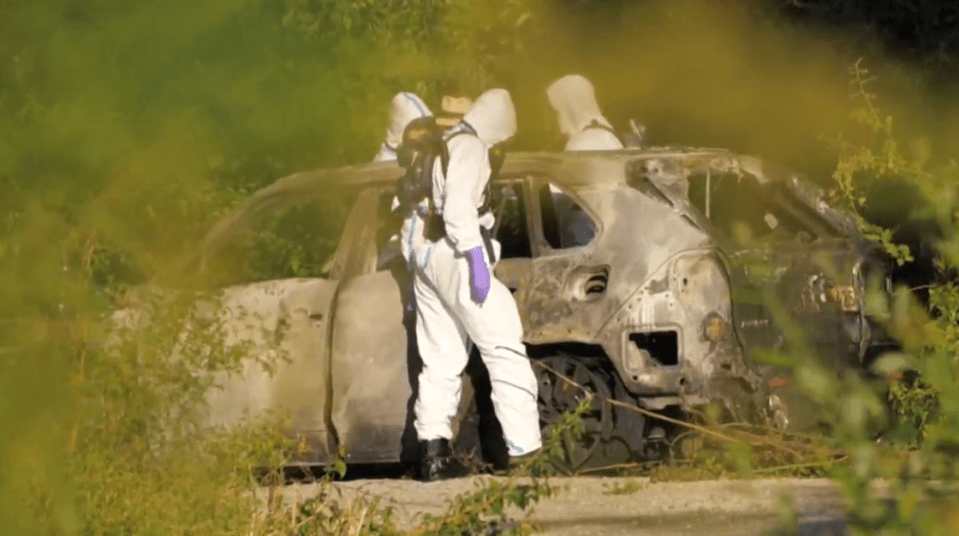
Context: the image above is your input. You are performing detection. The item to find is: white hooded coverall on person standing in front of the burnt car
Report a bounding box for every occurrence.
[411,89,542,456]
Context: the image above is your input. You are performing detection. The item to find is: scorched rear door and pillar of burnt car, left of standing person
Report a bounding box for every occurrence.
[329,182,430,464]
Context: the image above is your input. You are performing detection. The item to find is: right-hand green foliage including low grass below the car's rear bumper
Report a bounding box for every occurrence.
[668,63,959,534]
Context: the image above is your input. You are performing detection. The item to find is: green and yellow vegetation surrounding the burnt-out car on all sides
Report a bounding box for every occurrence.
[0,0,959,535]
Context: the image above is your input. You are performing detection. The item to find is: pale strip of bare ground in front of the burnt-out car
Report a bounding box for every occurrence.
[264,477,844,536]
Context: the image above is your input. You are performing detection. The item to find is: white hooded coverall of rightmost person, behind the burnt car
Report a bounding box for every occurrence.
[546,74,623,247]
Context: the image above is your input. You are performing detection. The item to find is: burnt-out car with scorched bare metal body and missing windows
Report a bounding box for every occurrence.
[158,149,890,466]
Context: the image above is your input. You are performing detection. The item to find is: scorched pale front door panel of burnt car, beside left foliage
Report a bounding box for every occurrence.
[206,279,337,463]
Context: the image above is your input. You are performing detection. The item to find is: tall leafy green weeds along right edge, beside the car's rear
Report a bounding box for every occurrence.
[767,60,959,534]
